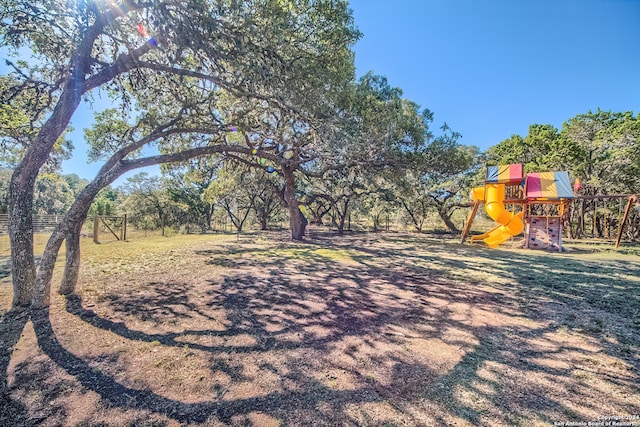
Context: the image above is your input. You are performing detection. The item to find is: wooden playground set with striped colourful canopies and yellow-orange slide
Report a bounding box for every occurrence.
[462,164,638,251]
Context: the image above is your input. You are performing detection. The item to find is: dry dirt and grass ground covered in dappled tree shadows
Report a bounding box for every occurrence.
[0,232,640,426]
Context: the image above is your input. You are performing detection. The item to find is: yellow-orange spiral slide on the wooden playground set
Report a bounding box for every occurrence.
[471,184,524,248]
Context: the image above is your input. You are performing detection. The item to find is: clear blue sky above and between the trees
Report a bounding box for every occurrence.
[5,0,640,183]
